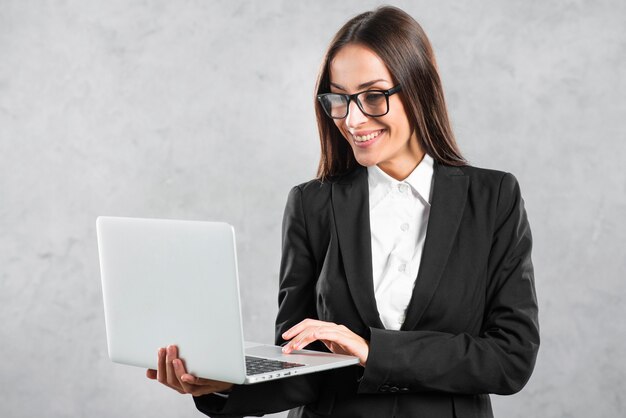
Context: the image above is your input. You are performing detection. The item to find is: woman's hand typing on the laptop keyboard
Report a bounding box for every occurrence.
[282,318,370,367]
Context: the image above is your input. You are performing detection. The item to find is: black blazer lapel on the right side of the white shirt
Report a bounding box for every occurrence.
[401,163,469,330]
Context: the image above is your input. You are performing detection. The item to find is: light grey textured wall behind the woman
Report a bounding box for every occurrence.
[0,0,626,417]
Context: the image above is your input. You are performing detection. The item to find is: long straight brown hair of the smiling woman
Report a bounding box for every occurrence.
[315,6,467,180]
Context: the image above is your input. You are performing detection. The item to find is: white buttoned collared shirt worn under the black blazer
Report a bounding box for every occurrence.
[367,154,434,330]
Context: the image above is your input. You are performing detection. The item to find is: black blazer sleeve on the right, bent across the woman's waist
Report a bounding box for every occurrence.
[358,174,539,394]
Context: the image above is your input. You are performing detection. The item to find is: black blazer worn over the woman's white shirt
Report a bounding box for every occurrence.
[194,163,539,418]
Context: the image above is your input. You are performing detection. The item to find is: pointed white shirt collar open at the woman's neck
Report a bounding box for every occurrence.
[367,154,434,207]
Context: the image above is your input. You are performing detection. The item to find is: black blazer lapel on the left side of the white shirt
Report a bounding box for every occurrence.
[332,168,384,328]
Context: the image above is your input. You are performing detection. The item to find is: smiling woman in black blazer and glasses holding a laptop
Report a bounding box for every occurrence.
[148,7,539,417]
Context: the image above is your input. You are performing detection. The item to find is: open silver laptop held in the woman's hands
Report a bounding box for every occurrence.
[96,216,358,384]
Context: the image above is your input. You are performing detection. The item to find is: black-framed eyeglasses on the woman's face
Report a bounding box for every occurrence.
[317,85,401,119]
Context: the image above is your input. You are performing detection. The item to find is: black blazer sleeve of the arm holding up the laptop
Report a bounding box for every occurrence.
[194,186,324,417]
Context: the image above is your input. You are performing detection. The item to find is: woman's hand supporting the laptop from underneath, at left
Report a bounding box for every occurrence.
[146,345,233,396]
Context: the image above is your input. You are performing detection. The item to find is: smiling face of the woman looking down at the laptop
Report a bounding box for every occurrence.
[330,44,424,180]
